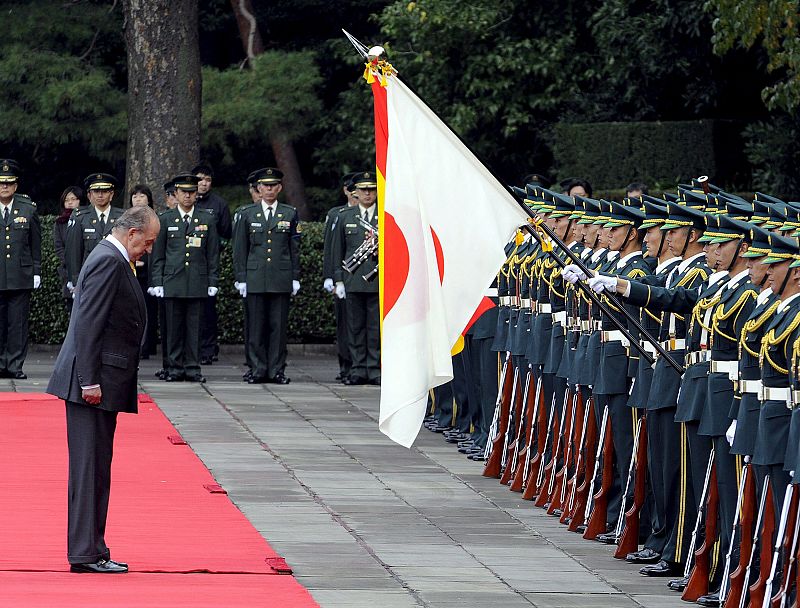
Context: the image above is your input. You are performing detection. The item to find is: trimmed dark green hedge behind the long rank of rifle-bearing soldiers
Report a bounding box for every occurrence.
[552,120,750,190]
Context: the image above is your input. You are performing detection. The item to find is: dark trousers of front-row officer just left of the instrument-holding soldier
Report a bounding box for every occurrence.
[245,293,289,378]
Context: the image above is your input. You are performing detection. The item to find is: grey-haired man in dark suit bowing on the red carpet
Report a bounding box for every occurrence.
[47,207,160,573]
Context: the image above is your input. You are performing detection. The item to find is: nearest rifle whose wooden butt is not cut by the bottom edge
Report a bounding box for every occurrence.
[681,448,719,602]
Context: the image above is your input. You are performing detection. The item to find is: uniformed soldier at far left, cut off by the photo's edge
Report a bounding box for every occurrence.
[0,159,42,380]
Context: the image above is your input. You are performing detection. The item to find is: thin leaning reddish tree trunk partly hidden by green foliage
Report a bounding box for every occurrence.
[231,0,311,220]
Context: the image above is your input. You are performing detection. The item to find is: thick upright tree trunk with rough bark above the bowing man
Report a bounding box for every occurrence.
[123,0,202,209]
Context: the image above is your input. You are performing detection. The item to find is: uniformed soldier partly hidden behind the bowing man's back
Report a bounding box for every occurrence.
[64,173,122,290]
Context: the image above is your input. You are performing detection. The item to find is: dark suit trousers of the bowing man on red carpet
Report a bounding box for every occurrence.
[64,401,117,564]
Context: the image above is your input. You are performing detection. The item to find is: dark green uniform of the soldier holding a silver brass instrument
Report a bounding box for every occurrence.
[333,203,381,384]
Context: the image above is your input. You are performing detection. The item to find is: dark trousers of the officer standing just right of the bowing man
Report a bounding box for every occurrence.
[164,298,205,377]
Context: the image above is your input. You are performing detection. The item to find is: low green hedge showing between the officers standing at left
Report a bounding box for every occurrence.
[30,216,336,344]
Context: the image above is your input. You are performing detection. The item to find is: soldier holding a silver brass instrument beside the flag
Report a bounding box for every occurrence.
[333,171,381,385]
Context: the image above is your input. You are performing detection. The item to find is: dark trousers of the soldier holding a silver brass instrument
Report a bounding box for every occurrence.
[346,292,381,380]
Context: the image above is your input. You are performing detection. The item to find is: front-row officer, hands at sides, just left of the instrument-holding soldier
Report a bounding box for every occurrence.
[238,167,300,384]
